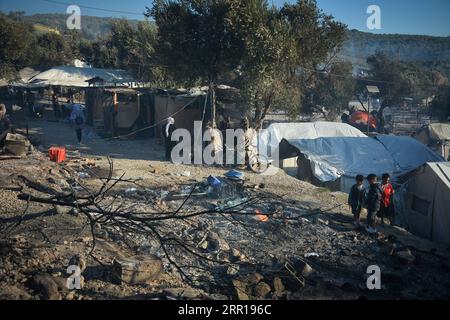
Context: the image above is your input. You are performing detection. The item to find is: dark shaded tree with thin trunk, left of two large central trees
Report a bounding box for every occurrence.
[147,0,242,126]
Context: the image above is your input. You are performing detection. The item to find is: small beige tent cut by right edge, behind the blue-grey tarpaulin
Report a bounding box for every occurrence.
[414,123,450,160]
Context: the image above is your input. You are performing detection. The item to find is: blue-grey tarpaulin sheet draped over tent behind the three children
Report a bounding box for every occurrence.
[287,136,444,182]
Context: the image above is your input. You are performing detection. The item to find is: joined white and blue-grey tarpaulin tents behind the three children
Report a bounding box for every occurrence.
[259,122,444,192]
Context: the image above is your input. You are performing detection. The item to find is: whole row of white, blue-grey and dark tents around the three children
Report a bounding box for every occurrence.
[259,122,450,244]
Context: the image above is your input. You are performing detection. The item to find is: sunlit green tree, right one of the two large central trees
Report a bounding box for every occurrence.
[239,0,346,128]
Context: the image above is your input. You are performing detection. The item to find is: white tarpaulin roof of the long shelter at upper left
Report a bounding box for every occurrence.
[29,66,134,87]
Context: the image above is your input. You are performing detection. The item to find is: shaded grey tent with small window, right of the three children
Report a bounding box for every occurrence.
[396,162,450,244]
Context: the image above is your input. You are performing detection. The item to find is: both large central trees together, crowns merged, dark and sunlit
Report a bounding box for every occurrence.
[148,0,345,128]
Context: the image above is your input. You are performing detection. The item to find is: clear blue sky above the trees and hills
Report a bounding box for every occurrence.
[0,0,450,36]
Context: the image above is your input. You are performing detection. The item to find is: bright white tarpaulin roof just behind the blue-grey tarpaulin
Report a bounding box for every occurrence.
[258,121,367,156]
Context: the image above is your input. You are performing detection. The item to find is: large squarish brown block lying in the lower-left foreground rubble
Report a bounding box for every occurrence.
[111,255,163,285]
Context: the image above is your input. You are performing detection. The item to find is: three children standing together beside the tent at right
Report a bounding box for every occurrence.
[348,173,395,234]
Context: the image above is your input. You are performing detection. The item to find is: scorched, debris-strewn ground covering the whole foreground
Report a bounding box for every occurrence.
[0,106,450,299]
